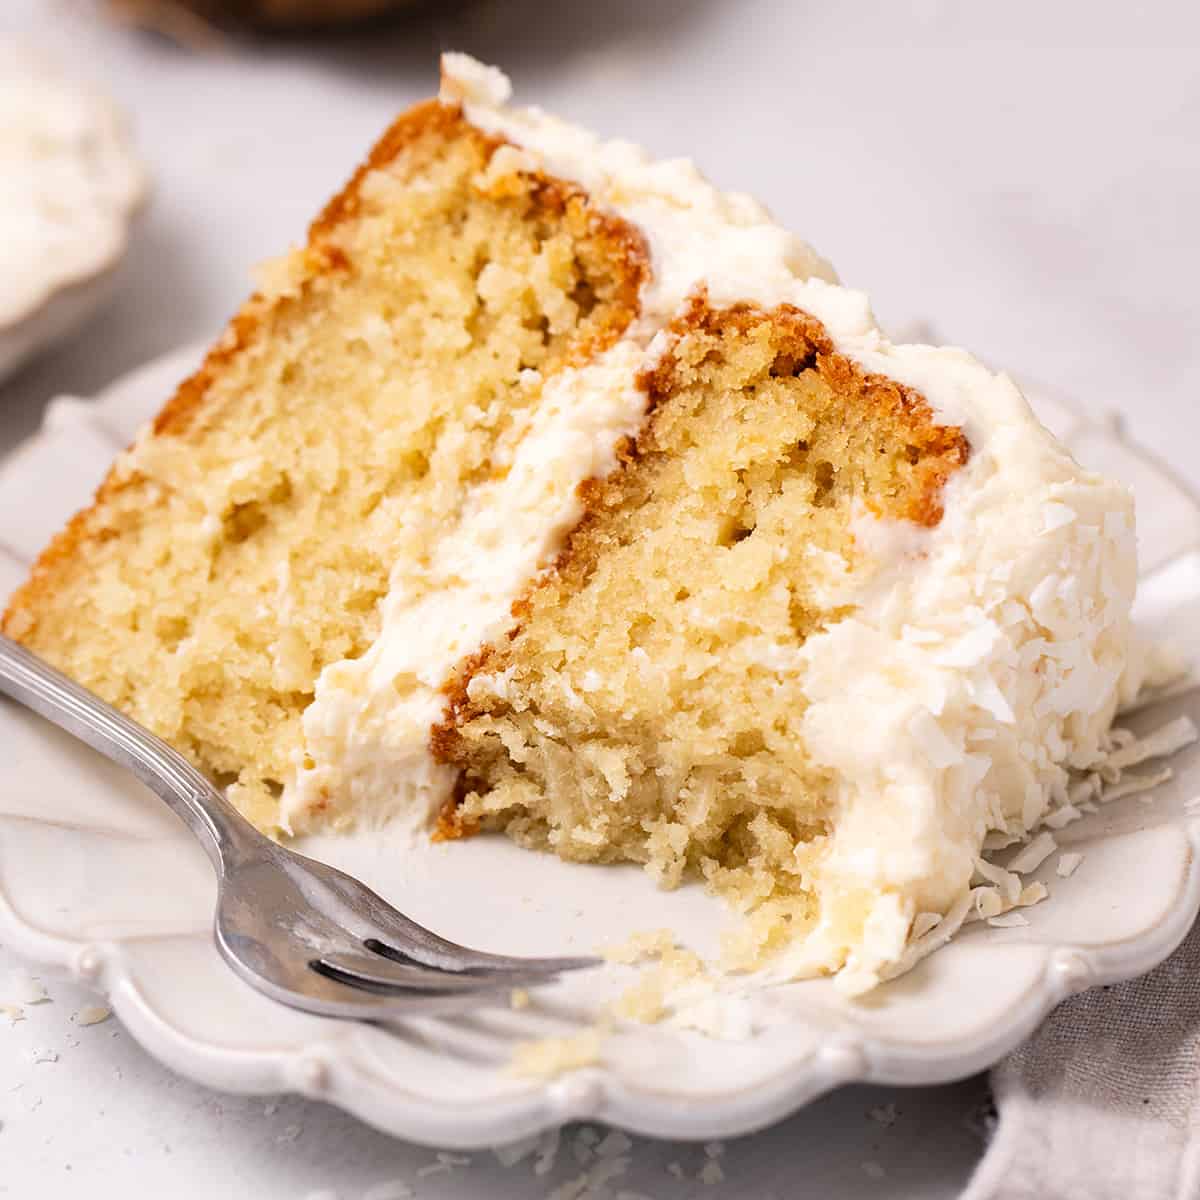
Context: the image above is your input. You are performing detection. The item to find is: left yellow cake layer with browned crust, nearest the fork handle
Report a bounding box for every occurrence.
[5,104,643,828]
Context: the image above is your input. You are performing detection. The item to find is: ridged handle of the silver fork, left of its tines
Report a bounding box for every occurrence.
[0,634,255,868]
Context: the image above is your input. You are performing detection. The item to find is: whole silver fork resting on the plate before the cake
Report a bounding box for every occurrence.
[0,635,599,1020]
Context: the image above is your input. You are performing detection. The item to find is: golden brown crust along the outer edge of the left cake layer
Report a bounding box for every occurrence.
[0,100,649,657]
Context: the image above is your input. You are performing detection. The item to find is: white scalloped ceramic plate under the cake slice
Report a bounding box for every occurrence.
[0,350,1200,1148]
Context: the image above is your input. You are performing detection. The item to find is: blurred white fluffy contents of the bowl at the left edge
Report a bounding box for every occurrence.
[0,42,145,328]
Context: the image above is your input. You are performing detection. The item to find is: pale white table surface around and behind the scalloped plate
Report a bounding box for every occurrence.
[0,0,1200,1200]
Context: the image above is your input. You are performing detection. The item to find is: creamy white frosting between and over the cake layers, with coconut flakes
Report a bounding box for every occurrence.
[289,54,1135,990]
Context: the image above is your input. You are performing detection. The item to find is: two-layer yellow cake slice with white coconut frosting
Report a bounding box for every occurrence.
[4,55,1135,989]
